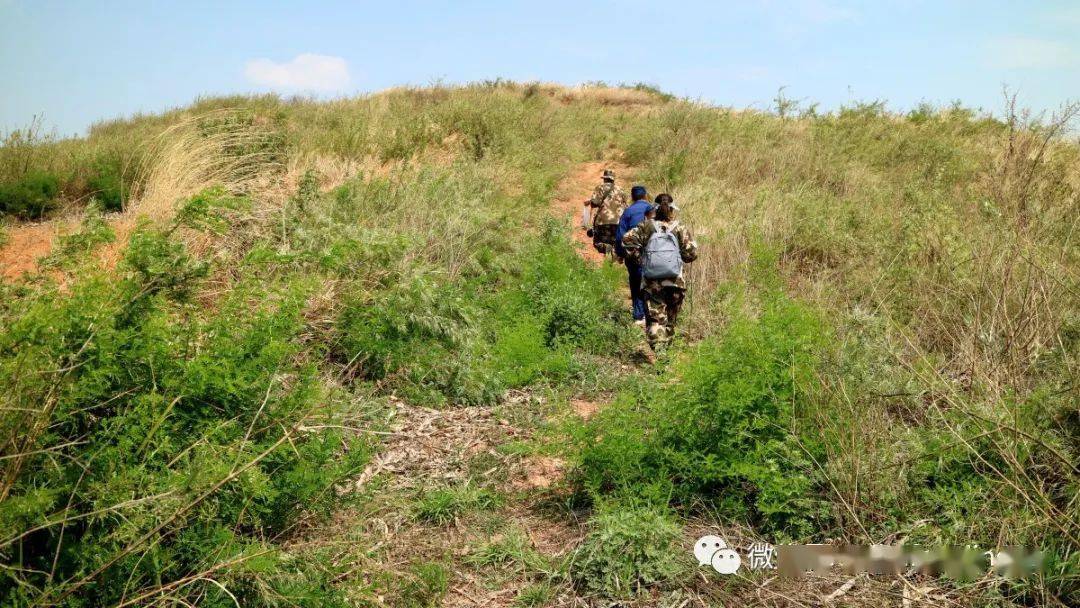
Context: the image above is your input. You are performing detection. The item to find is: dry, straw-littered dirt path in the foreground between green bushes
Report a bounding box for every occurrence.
[324,392,584,608]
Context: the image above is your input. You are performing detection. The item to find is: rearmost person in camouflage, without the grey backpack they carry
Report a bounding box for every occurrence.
[622,194,698,349]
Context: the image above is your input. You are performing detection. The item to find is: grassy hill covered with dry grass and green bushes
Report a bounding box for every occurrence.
[0,81,1080,607]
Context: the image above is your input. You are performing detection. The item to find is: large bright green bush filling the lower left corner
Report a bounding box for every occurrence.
[0,192,368,607]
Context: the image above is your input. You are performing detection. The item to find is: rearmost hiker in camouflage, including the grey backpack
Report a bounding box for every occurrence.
[622,194,698,350]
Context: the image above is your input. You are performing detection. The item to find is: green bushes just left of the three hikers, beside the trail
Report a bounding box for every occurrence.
[333,215,624,404]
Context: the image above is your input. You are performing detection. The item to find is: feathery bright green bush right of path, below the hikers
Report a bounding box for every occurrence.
[579,285,826,539]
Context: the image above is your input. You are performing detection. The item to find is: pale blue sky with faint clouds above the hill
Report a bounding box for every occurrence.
[0,0,1080,135]
